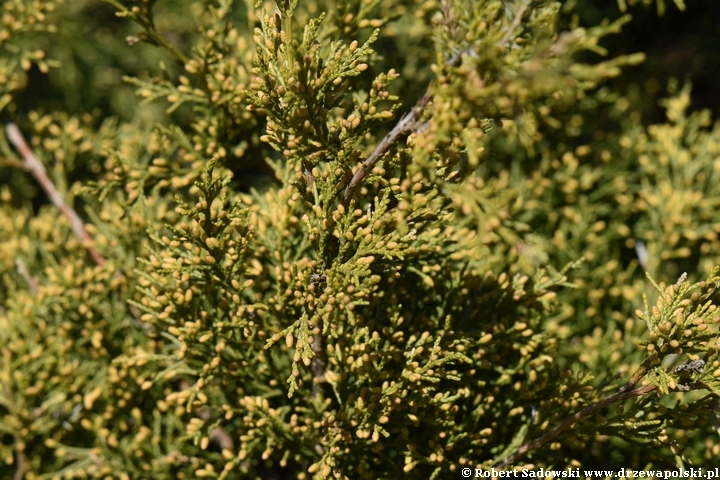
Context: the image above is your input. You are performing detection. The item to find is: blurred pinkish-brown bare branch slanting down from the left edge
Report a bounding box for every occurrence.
[5,122,105,265]
